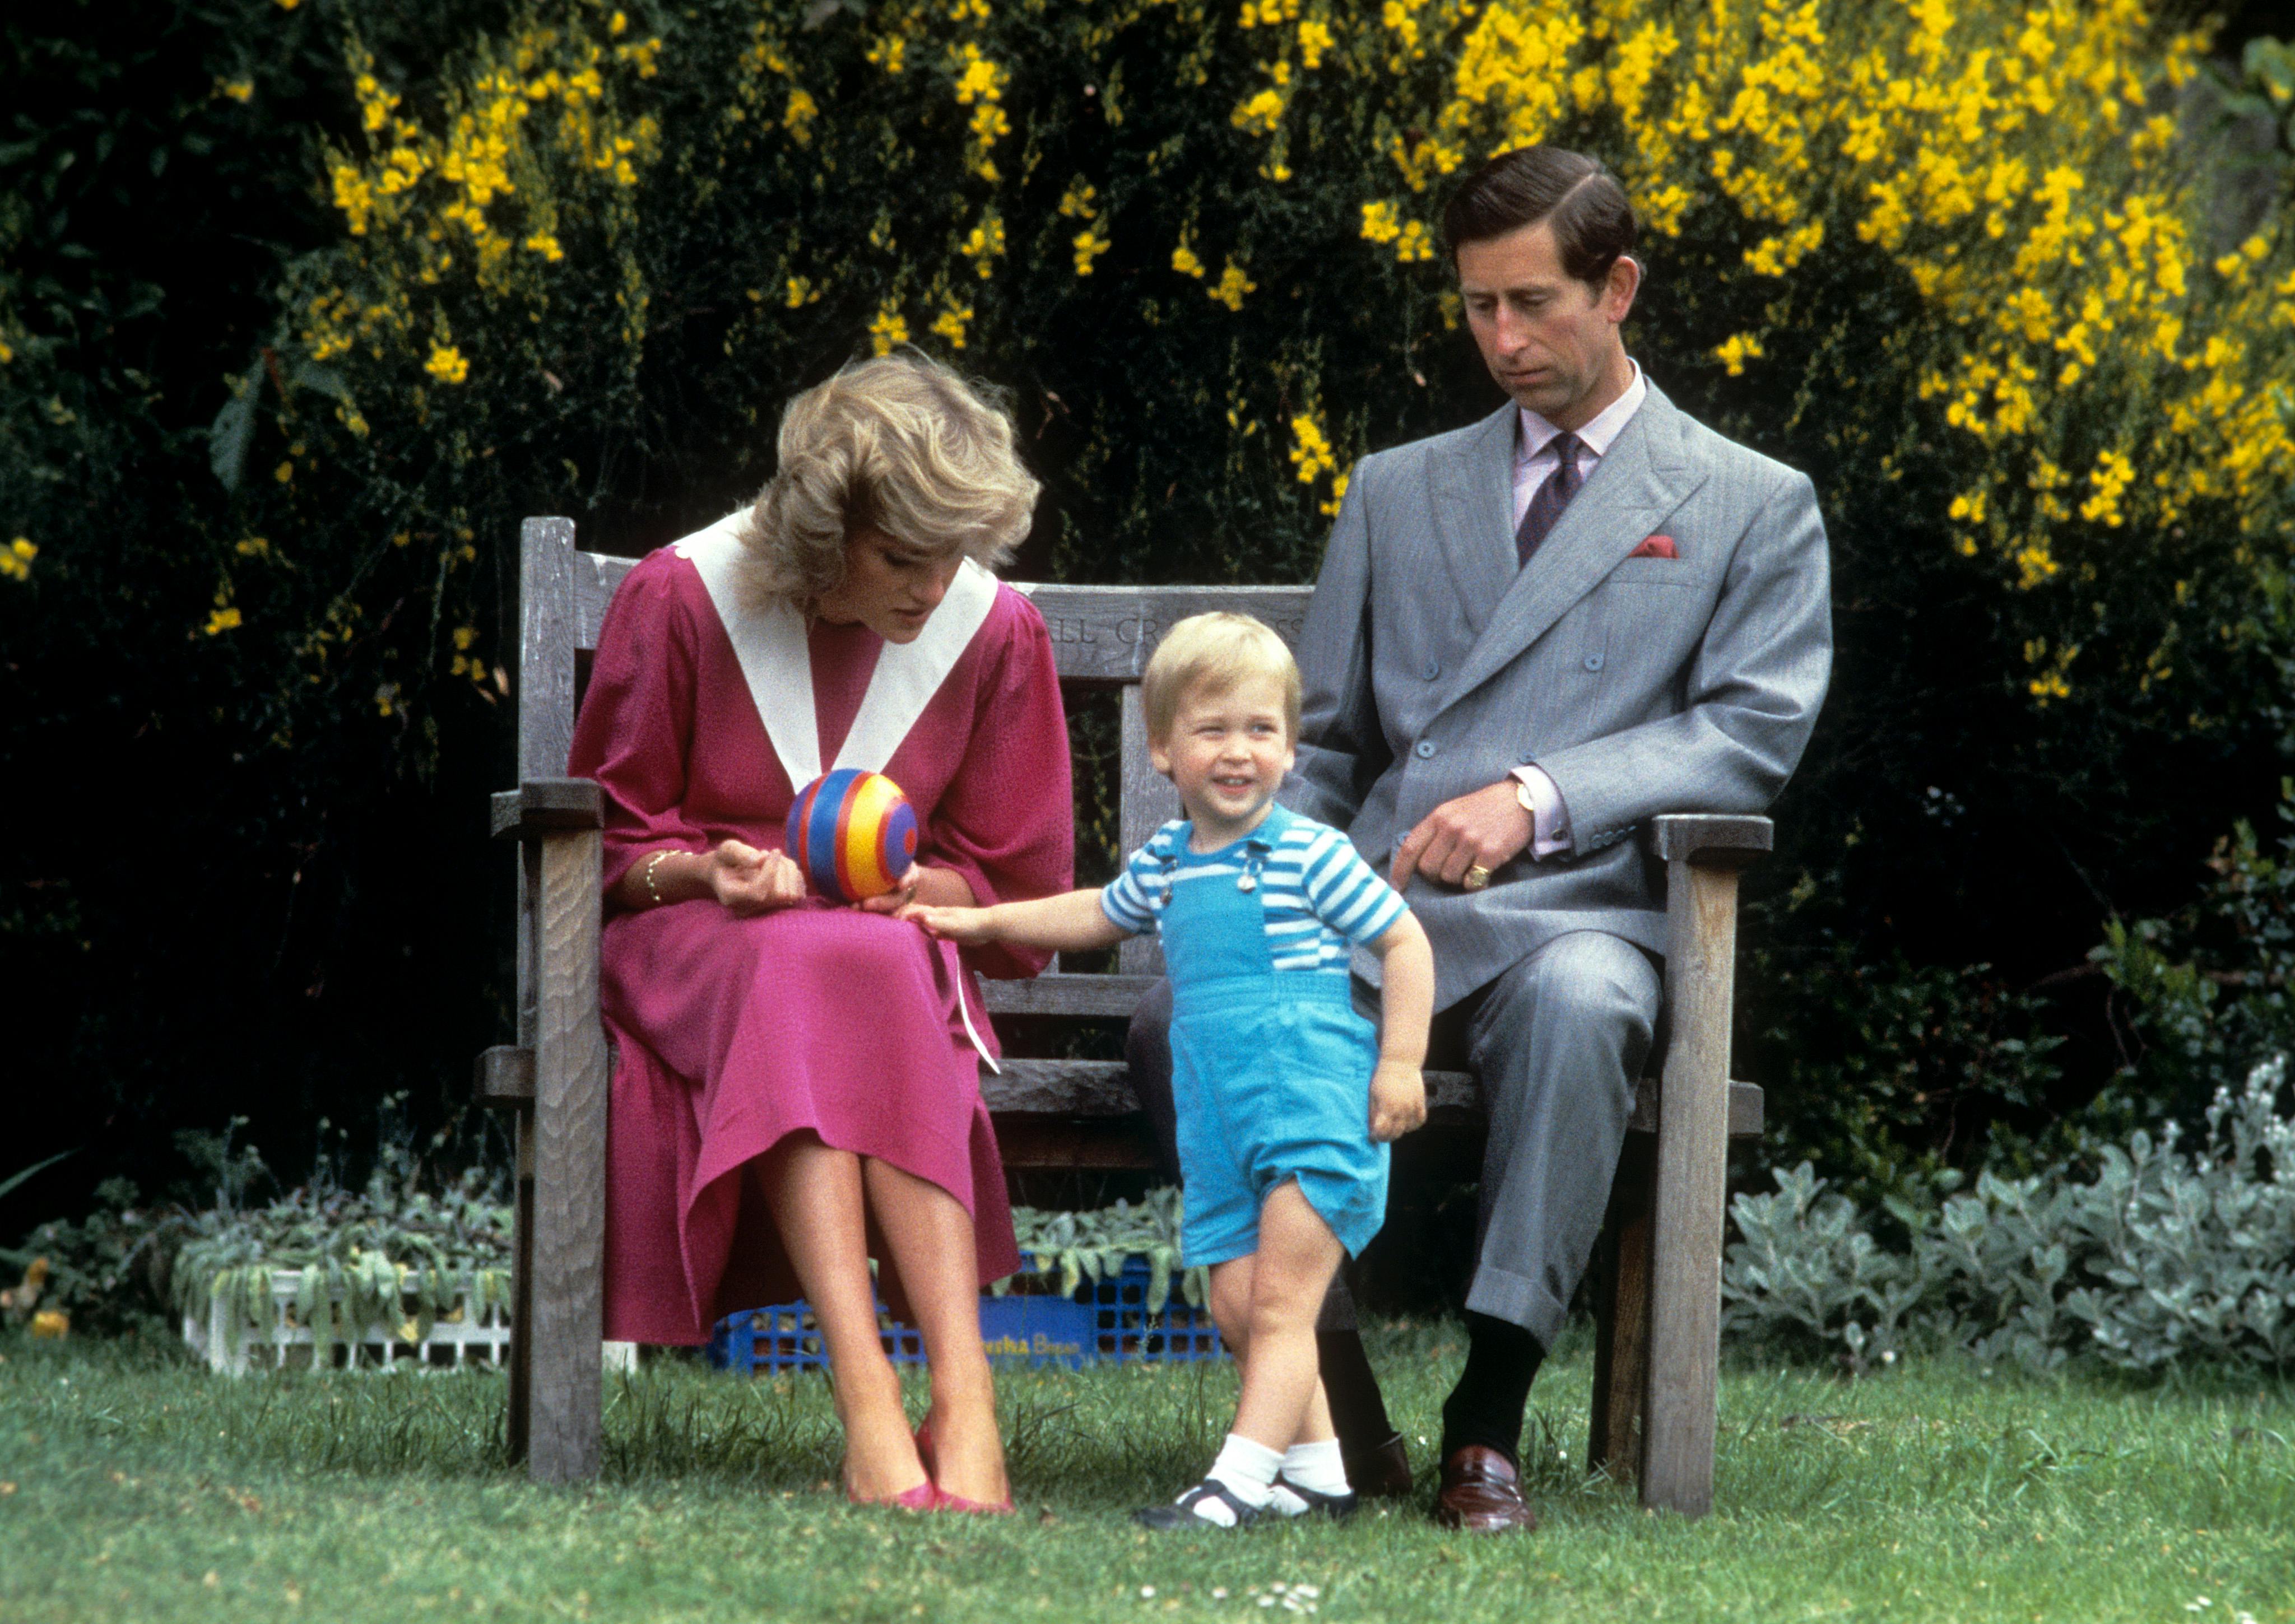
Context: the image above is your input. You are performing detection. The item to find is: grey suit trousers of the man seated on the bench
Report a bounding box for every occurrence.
[1127,931,1664,1347]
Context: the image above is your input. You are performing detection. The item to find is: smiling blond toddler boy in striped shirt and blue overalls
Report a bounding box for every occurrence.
[902,615,1434,1528]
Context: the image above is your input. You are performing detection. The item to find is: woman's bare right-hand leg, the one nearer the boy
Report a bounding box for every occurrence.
[861,1156,1012,1505]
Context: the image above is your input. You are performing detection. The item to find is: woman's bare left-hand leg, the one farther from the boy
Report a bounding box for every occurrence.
[760,1133,925,1500]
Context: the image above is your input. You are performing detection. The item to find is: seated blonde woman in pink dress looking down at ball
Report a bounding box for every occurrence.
[569,353,1072,1507]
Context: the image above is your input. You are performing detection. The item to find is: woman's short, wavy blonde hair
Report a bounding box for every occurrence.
[739,348,1042,603]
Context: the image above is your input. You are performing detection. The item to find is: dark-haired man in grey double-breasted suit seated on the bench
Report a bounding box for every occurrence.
[1133,147,1832,1532]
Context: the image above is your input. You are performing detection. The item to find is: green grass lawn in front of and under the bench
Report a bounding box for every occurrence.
[0,1324,2295,1624]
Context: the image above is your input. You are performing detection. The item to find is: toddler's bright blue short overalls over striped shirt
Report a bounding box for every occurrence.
[1159,823,1388,1264]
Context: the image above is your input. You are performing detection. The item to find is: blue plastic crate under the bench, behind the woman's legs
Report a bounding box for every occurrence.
[709,1257,1228,1376]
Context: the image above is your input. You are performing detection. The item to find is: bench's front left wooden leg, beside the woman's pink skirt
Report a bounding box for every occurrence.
[526,830,606,1482]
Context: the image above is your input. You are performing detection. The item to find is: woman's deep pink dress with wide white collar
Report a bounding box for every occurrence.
[567,525,1074,1344]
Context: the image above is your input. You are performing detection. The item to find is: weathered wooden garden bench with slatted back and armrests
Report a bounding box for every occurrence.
[477,518,1769,1514]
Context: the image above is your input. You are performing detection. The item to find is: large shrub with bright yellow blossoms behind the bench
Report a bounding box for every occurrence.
[211,0,2295,1160]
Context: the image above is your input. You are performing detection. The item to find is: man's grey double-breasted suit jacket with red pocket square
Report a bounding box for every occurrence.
[1283,383,1834,1007]
